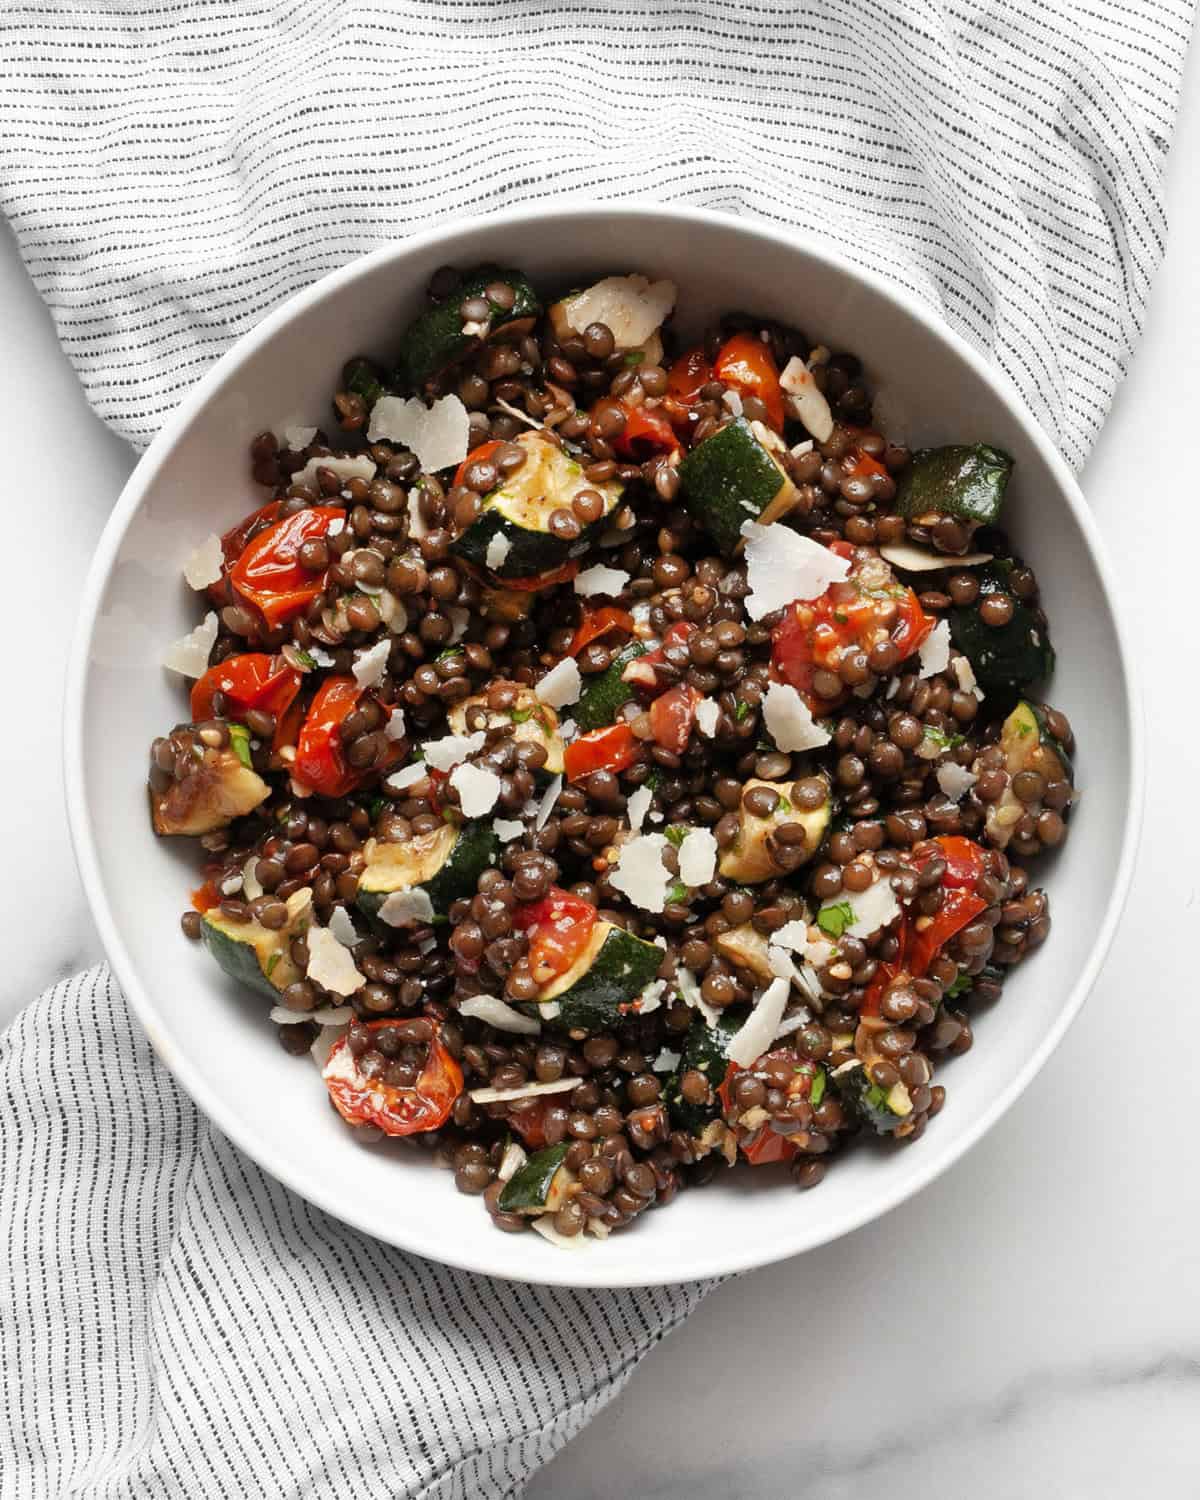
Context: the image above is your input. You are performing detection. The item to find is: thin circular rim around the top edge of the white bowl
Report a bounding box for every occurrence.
[62,197,1145,1287]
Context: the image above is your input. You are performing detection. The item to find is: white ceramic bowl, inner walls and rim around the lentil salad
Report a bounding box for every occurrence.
[66,204,1142,1286]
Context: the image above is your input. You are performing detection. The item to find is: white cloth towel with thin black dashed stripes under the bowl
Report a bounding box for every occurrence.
[0,0,1193,1500]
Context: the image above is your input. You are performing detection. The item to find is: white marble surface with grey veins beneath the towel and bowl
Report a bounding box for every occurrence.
[0,57,1200,1500]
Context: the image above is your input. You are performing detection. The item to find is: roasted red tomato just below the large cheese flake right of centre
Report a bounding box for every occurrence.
[771,542,933,711]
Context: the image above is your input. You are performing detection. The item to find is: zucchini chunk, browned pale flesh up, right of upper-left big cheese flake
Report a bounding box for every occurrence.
[452,432,623,578]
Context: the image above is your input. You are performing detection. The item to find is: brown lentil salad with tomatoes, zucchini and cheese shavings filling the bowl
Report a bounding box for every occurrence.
[150,266,1076,1248]
